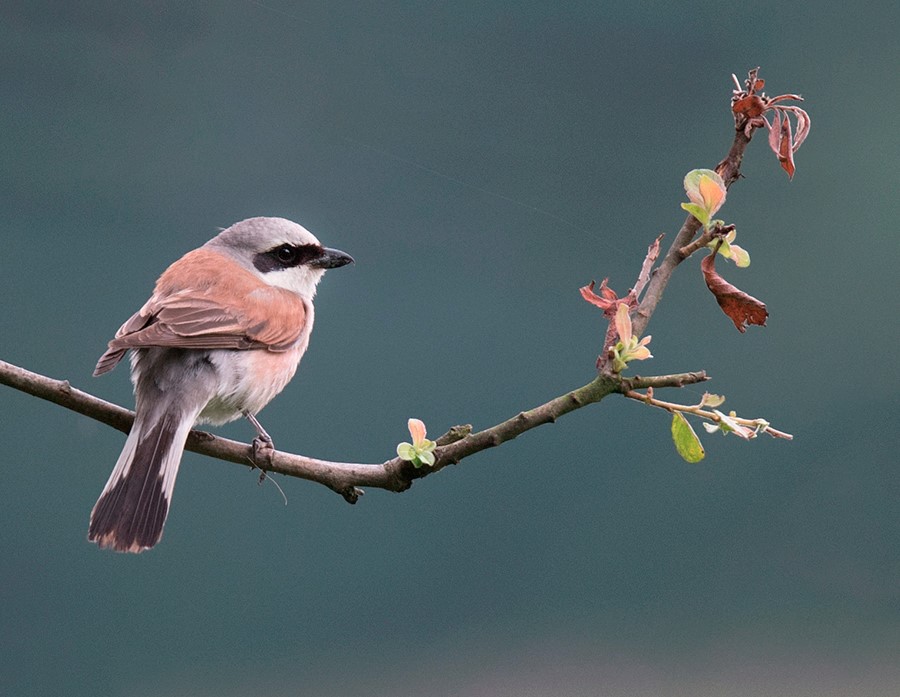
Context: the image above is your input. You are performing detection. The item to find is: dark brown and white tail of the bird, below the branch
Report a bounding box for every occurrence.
[88,409,194,552]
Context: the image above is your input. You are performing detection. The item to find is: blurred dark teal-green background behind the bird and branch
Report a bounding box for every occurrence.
[0,0,900,697]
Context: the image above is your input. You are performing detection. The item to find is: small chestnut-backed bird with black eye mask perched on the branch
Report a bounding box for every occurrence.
[88,217,353,553]
